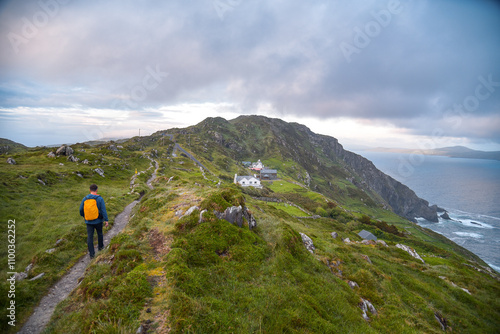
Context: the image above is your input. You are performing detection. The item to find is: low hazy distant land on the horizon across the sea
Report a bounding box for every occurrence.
[369,146,500,160]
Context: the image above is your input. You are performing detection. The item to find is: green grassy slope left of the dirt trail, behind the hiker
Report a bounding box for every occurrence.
[0,142,153,332]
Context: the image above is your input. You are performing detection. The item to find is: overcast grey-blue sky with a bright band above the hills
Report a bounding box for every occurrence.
[0,0,500,150]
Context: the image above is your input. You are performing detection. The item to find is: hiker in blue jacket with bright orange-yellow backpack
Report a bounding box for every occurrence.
[80,184,108,259]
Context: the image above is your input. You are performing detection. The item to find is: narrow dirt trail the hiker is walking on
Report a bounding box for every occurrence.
[18,159,159,334]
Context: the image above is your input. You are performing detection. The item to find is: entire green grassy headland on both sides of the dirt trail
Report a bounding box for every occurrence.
[0,119,500,333]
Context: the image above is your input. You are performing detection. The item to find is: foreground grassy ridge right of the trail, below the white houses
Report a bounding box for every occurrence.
[47,159,500,333]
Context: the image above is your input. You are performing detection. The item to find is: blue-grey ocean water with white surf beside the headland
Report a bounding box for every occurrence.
[358,151,500,272]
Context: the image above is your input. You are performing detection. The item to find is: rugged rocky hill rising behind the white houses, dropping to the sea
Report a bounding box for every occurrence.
[172,116,438,222]
